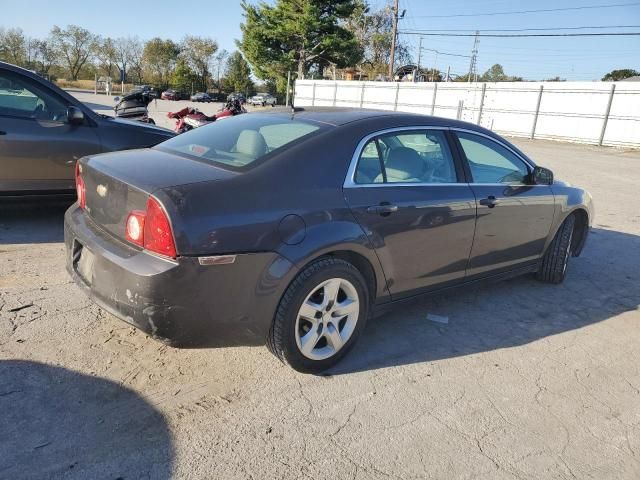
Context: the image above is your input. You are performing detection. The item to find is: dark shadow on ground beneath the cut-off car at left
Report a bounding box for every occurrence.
[0,202,74,245]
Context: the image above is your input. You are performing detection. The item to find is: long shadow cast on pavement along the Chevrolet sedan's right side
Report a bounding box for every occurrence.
[330,229,640,375]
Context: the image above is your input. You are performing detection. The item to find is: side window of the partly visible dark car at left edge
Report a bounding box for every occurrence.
[0,72,67,122]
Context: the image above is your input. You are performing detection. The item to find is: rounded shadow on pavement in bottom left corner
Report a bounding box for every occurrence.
[0,361,174,480]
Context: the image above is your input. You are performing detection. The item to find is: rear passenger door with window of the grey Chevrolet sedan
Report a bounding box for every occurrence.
[344,127,476,299]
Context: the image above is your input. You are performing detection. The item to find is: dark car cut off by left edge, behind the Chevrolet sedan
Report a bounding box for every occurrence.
[0,62,175,196]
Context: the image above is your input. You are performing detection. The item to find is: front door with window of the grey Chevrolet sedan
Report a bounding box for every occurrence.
[454,131,555,278]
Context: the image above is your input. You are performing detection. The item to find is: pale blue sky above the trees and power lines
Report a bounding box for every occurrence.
[0,0,640,80]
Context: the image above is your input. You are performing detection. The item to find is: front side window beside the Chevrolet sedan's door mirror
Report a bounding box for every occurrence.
[457,132,529,185]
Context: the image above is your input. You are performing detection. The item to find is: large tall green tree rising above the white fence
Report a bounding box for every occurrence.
[238,0,362,92]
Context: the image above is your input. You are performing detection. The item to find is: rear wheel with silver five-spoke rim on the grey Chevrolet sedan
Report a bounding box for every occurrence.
[267,257,369,373]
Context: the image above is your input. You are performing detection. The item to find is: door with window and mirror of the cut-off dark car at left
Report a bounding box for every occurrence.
[0,69,101,192]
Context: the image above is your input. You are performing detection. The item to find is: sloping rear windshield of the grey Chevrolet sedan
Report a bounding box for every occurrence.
[157,114,325,170]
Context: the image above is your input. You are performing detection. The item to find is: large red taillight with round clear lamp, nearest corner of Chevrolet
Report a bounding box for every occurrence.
[125,197,176,258]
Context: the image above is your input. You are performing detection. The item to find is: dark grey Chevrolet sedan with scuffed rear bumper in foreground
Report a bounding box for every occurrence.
[65,108,593,372]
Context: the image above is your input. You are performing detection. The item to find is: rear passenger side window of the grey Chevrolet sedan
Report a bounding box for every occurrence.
[354,130,457,184]
